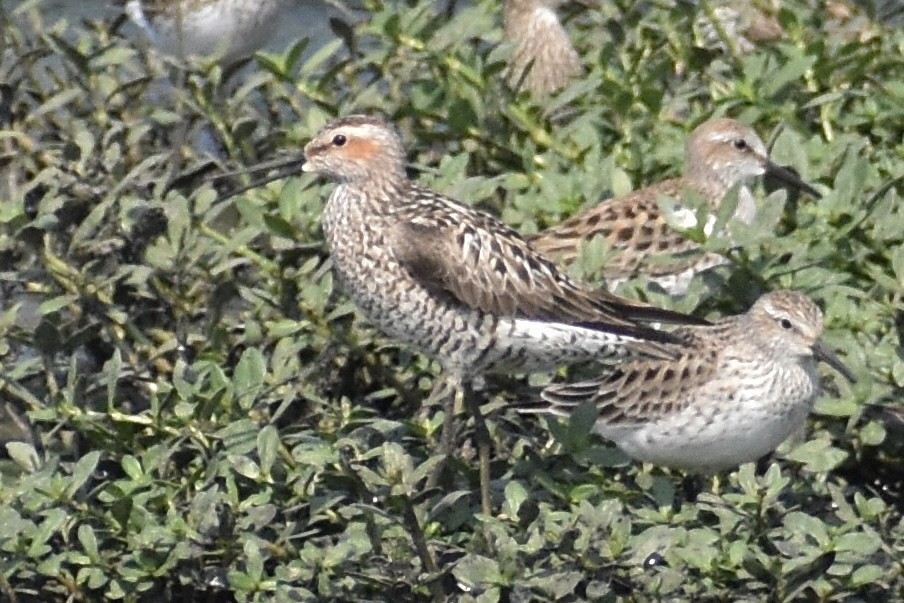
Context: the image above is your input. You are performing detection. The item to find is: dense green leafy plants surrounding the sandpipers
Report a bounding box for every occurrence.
[0,0,904,601]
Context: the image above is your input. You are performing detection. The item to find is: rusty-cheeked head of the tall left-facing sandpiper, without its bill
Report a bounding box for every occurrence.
[302,115,405,184]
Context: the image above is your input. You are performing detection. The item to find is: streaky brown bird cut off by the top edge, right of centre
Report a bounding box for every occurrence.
[502,0,581,96]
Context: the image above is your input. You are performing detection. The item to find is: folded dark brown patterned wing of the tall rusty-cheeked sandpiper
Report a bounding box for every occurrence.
[390,184,704,341]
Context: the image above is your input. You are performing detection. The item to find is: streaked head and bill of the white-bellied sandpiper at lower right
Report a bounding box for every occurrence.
[750,291,856,382]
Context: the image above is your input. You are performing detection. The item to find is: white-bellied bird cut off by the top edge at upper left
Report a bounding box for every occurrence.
[125,0,288,63]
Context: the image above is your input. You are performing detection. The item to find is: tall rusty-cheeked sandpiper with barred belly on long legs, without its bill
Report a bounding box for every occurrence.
[302,115,701,513]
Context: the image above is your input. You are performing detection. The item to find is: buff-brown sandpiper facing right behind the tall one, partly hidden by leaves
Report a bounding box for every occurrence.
[528,118,820,294]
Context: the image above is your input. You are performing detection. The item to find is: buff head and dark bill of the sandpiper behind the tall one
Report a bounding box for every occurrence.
[685,117,820,198]
